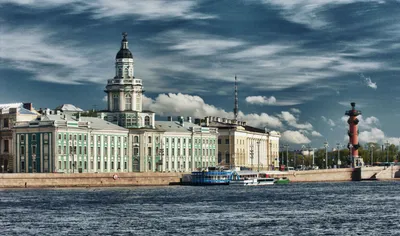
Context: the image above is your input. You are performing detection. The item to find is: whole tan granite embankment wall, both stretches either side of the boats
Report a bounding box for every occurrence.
[0,166,400,188]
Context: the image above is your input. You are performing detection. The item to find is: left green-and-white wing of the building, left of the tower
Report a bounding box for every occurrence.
[13,113,128,173]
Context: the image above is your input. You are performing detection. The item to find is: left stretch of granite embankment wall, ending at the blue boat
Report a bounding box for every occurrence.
[0,173,182,188]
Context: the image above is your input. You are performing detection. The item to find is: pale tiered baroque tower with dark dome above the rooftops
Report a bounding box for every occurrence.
[102,32,155,128]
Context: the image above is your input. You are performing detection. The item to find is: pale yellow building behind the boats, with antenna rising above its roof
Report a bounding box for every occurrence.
[202,116,280,170]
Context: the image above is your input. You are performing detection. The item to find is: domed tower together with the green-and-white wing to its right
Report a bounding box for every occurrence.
[97,33,218,172]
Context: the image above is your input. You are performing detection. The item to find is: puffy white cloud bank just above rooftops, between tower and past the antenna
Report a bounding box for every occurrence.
[143,93,282,129]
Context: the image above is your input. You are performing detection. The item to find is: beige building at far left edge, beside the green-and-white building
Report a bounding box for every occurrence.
[0,103,38,172]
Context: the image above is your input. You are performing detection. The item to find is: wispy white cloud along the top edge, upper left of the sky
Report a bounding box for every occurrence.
[0,0,215,20]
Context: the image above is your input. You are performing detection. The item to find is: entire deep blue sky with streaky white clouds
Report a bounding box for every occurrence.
[0,0,400,149]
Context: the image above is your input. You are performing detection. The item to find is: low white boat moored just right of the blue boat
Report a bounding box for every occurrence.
[229,171,274,186]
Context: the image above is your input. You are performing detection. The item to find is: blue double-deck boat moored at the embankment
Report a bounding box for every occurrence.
[189,167,232,185]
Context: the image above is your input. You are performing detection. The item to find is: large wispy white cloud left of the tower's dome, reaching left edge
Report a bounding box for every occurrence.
[0,27,112,84]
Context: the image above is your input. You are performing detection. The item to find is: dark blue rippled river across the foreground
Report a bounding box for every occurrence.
[0,181,400,235]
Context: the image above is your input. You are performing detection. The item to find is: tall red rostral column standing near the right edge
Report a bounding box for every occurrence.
[345,102,361,167]
